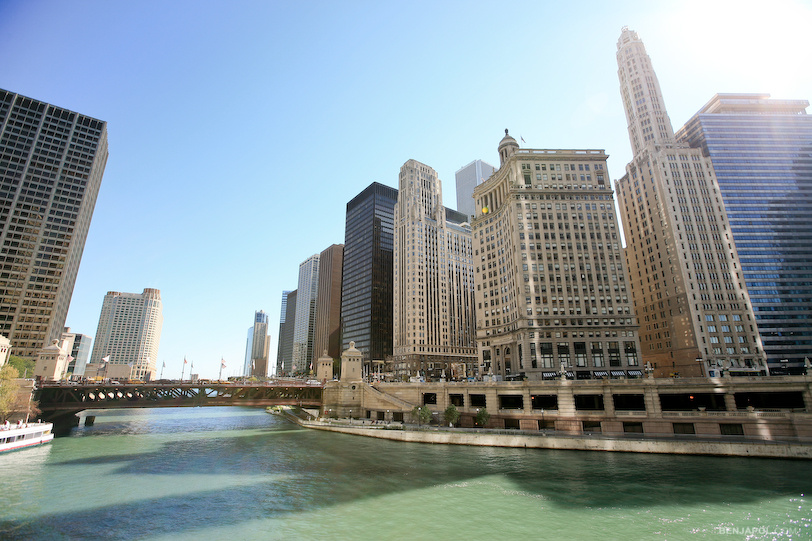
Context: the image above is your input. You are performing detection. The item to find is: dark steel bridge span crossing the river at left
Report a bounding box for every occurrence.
[34,382,324,422]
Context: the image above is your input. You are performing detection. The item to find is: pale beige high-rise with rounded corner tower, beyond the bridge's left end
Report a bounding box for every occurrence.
[90,288,164,381]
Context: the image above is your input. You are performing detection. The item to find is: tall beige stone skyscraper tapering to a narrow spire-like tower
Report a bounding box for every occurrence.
[616,28,767,376]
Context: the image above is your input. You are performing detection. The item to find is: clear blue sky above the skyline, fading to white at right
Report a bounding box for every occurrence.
[0,0,812,377]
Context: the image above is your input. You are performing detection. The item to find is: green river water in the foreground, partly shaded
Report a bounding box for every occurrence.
[0,407,812,541]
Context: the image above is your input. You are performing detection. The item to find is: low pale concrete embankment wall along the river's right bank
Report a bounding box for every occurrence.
[286,415,812,459]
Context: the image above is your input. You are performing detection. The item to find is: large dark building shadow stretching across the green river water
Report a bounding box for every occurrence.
[0,412,812,539]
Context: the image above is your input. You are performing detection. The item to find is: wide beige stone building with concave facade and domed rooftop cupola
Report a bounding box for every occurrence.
[472,130,643,380]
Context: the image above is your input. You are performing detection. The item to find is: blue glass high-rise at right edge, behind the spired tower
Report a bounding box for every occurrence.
[676,94,812,374]
